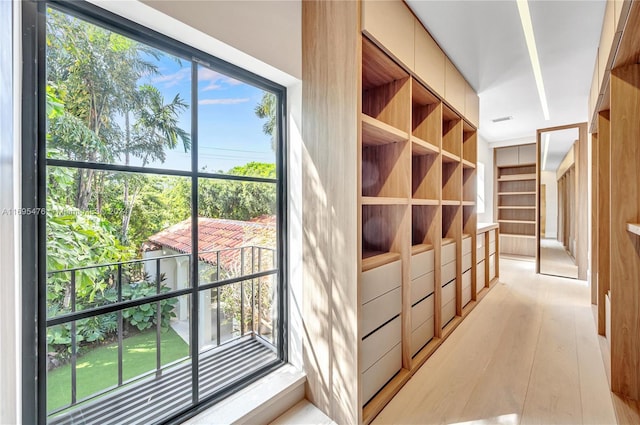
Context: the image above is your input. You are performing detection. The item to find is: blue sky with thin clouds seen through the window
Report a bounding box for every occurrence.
[132,47,275,172]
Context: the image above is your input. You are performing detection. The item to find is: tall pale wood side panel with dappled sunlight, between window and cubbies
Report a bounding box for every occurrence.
[302,1,361,424]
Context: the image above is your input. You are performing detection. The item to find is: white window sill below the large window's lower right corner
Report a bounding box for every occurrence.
[183,364,306,425]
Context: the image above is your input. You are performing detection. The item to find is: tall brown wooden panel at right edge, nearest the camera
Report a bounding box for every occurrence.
[610,65,640,400]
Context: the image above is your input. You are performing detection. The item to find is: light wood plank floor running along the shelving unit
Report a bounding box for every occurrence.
[373,259,615,424]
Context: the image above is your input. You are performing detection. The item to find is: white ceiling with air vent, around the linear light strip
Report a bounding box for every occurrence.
[406,0,605,145]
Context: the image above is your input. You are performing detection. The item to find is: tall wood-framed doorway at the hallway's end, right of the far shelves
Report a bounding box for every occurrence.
[536,124,587,279]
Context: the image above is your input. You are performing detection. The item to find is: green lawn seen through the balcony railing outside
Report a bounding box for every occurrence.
[47,328,189,410]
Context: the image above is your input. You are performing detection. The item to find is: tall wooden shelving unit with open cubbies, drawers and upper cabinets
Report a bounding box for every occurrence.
[302,1,488,424]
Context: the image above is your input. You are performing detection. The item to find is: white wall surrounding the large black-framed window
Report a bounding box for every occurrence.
[0,0,302,424]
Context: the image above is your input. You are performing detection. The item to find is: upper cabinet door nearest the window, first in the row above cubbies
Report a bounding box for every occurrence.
[362,0,415,71]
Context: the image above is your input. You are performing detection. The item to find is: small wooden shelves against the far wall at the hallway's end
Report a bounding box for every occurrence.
[495,159,538,257]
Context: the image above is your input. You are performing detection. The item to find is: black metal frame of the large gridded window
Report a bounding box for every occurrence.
[21,0,289,424]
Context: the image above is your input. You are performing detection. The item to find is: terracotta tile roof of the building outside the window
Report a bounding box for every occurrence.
[142,216,276,264]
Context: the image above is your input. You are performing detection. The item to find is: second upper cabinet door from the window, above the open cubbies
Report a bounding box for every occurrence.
[415,21,445,97]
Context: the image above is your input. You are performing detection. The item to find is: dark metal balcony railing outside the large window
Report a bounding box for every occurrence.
[47,246,278,417]
